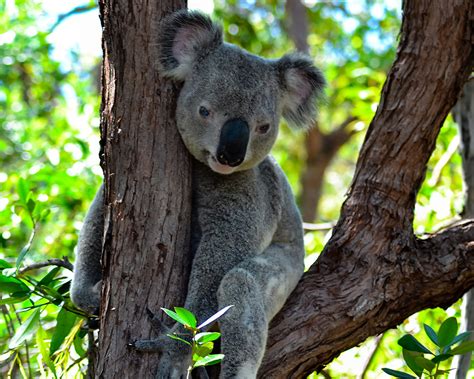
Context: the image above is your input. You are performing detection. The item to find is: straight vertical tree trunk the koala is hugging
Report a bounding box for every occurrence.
[96,0,191,378]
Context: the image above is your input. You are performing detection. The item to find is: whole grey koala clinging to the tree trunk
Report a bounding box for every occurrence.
[71,11,324,379]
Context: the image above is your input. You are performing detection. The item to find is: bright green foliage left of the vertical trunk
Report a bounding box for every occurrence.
[0,0,99,378]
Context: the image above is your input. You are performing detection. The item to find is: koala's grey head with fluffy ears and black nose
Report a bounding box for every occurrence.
[158,11,324,174]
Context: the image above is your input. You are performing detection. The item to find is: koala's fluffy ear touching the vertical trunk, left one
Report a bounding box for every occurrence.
[158,10,222,81]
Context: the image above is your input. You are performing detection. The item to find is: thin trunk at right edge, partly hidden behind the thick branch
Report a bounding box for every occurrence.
[450,80,474,379]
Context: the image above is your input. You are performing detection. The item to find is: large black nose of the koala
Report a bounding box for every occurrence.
[216,118,250,167]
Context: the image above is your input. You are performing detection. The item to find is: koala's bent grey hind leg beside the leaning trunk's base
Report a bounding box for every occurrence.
[217,244,303,379]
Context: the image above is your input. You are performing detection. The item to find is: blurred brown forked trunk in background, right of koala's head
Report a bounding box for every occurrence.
[285,0,355,222]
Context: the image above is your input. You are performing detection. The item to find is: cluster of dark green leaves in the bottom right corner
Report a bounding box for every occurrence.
[382,317,474,379]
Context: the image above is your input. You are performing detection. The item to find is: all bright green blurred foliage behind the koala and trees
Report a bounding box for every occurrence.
[0,0,463,378]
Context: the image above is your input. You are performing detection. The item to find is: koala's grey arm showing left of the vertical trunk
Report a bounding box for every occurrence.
[71,185,104,314]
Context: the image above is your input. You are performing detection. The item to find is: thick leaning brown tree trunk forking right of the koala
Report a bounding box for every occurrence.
[259,0,474,378]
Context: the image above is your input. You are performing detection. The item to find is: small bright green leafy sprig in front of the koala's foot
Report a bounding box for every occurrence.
[161,305,233,378]
